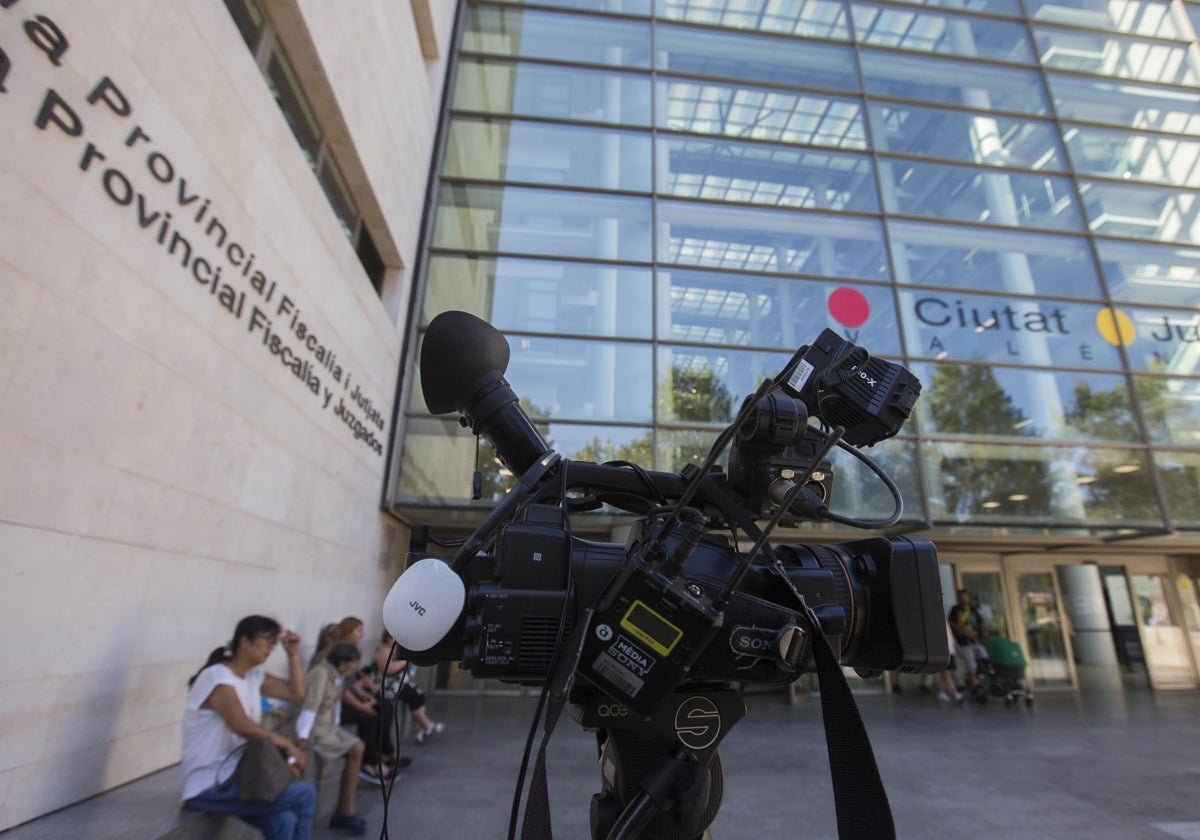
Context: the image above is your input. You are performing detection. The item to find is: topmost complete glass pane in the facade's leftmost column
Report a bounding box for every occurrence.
[462,7,650,67]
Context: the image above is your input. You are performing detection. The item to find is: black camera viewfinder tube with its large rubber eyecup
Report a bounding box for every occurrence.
[421,310,550,475]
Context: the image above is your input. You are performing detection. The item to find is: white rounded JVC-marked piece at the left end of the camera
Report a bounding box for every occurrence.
[383,557,467,652]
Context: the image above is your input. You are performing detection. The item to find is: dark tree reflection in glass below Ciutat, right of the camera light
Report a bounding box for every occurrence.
[922,365,1054,522]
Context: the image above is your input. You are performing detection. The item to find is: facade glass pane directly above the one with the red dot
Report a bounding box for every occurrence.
[658,202,888,280]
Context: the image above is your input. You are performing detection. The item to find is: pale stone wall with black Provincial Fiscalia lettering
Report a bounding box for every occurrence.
[0,0,454,829]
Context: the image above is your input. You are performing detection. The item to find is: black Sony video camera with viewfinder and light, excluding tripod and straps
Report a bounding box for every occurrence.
[384,311,948,719]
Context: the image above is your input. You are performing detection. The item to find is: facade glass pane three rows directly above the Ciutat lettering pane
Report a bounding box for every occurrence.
[870,102,1067,169]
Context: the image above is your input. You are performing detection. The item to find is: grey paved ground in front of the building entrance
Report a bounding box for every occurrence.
[4,690,1200,840]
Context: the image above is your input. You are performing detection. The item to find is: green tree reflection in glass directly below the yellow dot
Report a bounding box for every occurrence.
[1064,382,1160,522]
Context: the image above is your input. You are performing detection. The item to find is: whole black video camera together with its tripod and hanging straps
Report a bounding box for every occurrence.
[383,312,949,840]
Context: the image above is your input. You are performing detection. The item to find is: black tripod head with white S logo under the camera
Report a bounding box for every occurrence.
[566,684,746,840]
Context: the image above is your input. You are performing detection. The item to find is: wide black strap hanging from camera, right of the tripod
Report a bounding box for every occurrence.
[812,628,896,840]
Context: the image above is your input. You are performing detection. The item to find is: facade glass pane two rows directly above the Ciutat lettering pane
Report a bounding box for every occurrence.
[880,158,1084,230]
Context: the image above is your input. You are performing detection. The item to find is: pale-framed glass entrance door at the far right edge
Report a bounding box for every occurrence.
[1129,571,1196,689]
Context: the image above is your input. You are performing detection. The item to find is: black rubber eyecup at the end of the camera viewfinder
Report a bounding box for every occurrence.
[421,310,509,414]
